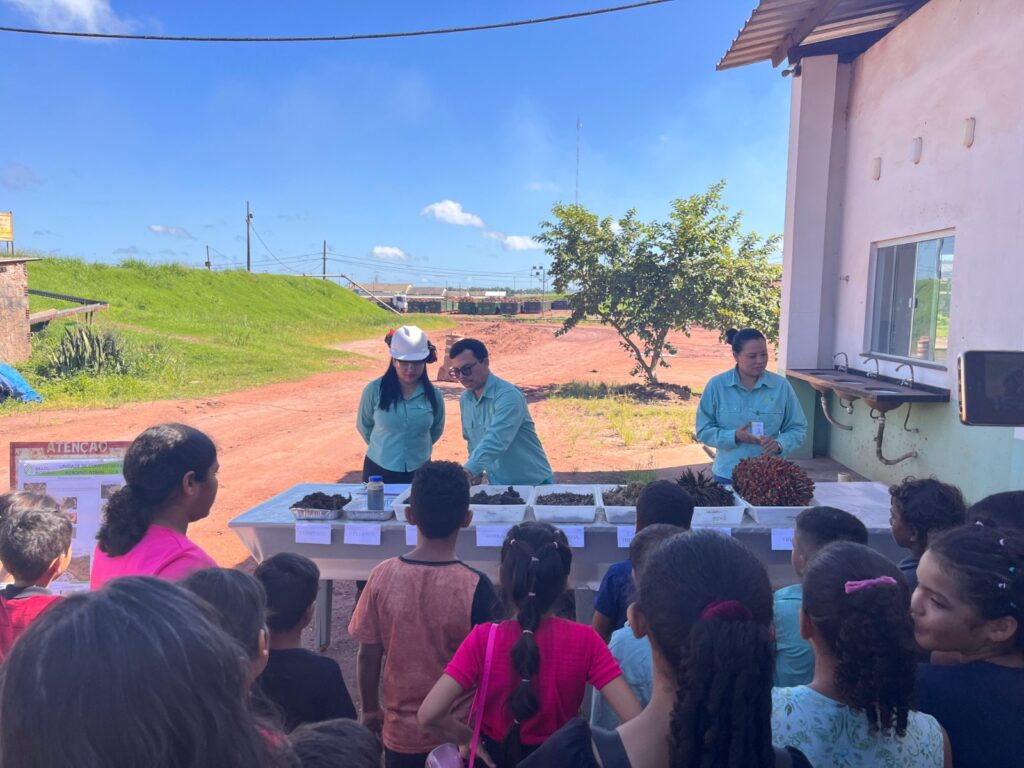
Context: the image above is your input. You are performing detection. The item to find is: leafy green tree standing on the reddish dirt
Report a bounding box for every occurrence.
[537,181,782,384]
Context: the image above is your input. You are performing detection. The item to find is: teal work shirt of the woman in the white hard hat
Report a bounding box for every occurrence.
[355,377,444,472]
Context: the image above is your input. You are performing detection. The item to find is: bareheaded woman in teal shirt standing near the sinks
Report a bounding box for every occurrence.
[697,328,807,483]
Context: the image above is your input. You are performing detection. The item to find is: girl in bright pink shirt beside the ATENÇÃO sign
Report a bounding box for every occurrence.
[90,424,220,589]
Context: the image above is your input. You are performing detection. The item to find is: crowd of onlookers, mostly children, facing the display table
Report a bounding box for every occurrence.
[0,424,1024,768]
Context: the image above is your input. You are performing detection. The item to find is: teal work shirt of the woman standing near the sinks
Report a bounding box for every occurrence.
[697,368,807,477]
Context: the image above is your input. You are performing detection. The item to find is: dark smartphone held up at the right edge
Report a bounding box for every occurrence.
[956,350,1024,427]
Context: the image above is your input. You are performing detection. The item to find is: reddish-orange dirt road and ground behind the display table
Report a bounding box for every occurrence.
[0,321,731,565]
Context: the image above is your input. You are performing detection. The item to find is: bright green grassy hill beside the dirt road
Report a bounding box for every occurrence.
[6,258,451,409]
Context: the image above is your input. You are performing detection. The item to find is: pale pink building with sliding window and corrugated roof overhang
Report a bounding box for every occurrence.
[719,0,1024,500]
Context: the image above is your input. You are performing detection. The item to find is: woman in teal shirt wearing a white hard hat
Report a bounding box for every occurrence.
[355,326,444,483]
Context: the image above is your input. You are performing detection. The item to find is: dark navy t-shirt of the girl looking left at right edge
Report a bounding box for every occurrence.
[918,662,1024,768]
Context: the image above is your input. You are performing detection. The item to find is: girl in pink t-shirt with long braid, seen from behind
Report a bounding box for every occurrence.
[419,522,640,768]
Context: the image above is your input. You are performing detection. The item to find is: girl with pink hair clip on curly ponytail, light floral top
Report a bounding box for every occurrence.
[772,542,952,768]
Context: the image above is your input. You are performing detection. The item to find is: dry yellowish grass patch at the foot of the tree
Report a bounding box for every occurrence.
[548,382,696,450]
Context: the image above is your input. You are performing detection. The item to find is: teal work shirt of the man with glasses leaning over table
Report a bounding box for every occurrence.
[459,374,554,485]
